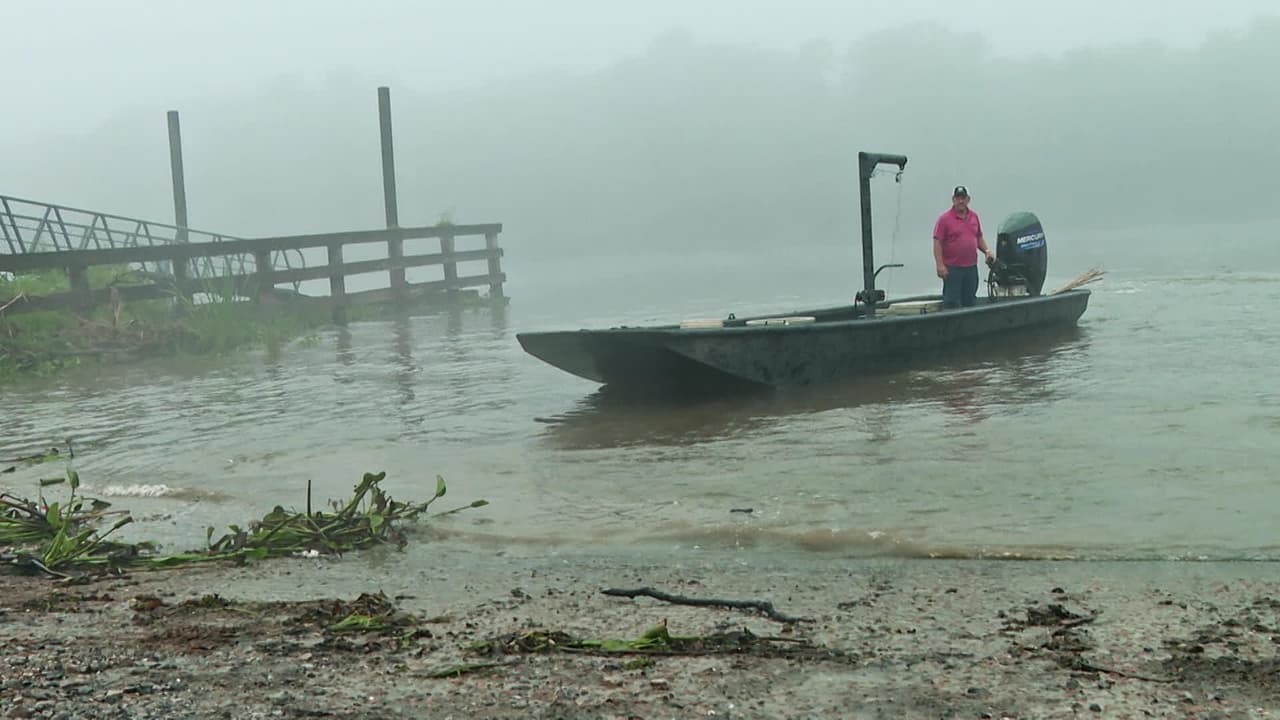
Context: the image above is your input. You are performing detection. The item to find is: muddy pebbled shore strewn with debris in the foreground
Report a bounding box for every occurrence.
[0,548,1280,719]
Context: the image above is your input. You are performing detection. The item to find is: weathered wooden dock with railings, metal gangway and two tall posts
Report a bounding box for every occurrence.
[0,87,507,323]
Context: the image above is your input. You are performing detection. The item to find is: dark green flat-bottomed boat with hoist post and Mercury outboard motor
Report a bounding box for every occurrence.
[516,152,1089,393]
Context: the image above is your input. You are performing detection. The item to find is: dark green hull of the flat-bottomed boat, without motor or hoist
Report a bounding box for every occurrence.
[517,290,1089,392]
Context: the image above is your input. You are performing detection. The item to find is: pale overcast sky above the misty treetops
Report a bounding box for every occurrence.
[0,0,1280,140]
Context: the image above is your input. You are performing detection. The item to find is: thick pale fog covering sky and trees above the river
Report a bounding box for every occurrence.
[0,0,1280,258]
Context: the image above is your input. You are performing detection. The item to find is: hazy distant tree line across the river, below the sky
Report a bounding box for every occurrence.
[0,18,1280,254]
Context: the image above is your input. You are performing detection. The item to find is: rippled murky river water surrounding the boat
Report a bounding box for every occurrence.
[0,219,1280,560]
